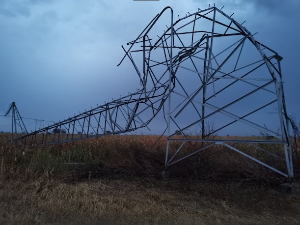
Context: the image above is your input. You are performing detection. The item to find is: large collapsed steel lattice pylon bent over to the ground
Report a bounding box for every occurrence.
[18,6,294,179]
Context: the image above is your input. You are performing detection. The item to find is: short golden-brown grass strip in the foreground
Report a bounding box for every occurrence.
[0,177,300,224]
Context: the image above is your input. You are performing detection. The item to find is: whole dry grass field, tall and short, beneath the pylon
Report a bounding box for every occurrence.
[0,134,300,225]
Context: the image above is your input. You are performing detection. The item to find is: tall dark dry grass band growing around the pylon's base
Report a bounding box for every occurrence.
[0,134,299,182]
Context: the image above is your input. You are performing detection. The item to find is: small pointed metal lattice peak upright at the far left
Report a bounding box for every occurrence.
[5,102,28,140]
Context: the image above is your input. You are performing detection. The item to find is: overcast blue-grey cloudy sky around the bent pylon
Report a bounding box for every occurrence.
[0,0,300,134]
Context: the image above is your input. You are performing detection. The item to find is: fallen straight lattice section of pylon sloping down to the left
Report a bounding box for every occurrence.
[16,88,167,145]
